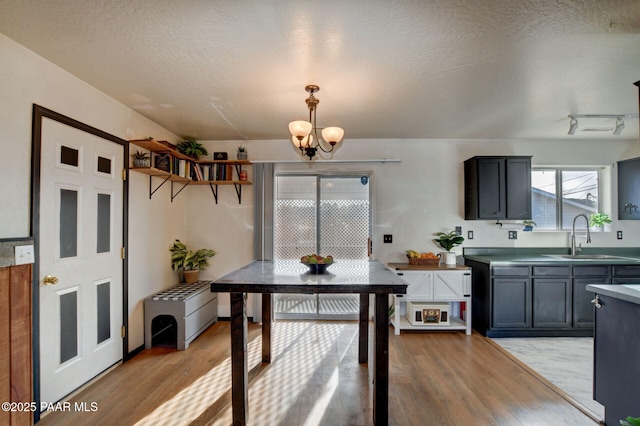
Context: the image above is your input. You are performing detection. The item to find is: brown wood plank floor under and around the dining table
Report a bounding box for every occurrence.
[39,321,596,426]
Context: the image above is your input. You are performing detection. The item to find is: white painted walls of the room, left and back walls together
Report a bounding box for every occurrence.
[0,31,640,349]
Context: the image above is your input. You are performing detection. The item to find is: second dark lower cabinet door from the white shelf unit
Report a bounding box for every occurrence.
[532,278,572,328]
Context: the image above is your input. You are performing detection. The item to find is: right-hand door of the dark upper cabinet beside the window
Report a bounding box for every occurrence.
[505,157,531,220]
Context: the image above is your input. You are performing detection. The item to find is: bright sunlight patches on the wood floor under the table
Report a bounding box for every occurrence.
[136,321,358,426]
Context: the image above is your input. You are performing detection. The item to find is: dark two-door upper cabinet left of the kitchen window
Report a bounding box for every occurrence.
[464,156,531,220]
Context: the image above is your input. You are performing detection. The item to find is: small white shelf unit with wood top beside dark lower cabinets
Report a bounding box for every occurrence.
[389,263,471,335]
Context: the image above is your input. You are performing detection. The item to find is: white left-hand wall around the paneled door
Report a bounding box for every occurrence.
[0,34,186,349]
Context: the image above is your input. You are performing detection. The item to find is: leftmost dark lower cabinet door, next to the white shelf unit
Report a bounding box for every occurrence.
[491,278,531,328]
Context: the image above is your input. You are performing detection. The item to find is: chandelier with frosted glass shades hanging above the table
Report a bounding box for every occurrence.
[289,84,344,160]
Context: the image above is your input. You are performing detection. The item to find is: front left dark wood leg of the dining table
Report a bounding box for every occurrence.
[230,293,249,426]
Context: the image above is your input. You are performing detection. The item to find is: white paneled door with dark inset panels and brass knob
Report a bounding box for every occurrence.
[39,118,124,403]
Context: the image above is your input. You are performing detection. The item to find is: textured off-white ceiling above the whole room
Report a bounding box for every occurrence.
[0,0,640,140]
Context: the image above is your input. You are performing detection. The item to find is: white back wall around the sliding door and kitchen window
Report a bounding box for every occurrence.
[198,138,640,316]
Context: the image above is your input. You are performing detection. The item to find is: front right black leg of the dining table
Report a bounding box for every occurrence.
[373,294,389,425]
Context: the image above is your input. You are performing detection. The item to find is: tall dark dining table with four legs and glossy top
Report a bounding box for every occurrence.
[211,260,407,425]
